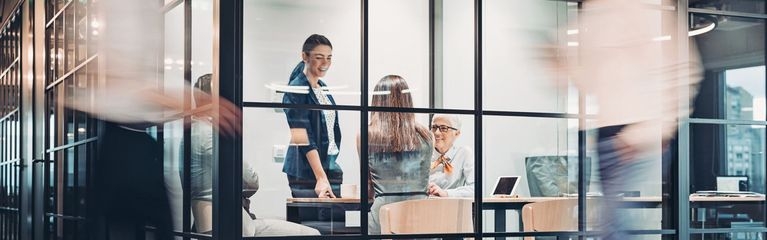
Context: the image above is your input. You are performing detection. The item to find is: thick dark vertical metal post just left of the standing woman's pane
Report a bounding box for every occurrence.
[213,0,243,239]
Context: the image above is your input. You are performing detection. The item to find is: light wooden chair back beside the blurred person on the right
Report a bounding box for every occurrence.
[522,198,601,240]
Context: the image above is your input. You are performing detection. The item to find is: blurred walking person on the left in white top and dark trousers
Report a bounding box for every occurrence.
[67,0,241,240]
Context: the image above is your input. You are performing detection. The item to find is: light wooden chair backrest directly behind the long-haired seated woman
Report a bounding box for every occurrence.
[379,198,474,234]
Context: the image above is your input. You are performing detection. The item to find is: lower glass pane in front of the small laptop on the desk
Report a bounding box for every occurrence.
[482,116,580,232]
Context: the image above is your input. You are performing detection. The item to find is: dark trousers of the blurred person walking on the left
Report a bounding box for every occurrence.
[86,122,172,240]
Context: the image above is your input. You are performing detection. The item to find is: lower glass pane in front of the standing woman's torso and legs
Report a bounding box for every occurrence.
[242,108,365,236]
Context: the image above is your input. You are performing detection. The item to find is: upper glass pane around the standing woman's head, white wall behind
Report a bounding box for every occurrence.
[242,0,364,106]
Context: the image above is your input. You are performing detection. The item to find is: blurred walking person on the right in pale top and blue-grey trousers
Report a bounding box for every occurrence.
[570,0,701,240]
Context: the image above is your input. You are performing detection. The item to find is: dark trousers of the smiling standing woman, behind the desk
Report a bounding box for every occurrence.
[288,175,346,221]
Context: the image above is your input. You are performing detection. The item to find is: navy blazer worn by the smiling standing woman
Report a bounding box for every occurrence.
[282,62,343,179]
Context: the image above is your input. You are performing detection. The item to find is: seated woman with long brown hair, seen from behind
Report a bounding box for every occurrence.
[357,75,434,234]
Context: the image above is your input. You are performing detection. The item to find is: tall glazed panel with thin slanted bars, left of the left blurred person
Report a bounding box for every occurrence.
[40,1,100,239]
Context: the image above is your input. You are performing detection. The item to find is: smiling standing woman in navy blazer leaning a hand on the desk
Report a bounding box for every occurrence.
[282,34,343,201]
